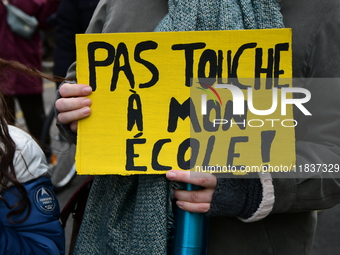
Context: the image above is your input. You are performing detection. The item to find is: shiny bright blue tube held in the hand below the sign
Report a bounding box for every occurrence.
[170,183,208,255]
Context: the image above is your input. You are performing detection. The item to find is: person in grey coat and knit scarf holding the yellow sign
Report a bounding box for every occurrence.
[56,0,340,255]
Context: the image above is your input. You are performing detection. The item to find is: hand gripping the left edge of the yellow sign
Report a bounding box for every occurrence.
[55,83,92,132]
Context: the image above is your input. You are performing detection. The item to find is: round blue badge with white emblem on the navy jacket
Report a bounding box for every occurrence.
[35,187,57,213]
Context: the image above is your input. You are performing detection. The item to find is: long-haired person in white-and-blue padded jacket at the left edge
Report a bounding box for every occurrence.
[0,59,65,255]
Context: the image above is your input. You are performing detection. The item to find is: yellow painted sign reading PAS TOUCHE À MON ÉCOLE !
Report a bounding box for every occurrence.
[76,29,296,175]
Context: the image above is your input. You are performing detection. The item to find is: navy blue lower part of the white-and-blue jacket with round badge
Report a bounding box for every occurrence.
[0,177,65,255]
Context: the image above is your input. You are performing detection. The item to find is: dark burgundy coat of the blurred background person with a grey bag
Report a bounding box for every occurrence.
[0,0,59,95]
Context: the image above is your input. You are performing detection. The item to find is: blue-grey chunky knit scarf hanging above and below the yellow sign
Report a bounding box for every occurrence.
[74,0,283,255]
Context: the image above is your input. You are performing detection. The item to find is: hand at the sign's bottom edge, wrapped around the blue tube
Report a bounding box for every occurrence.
[166,170,217,213]
